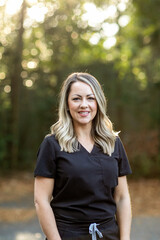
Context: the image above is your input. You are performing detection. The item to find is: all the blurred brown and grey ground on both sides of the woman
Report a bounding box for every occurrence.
[0,173,160,240]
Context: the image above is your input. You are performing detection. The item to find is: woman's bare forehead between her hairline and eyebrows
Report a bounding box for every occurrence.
[70,81,94,95]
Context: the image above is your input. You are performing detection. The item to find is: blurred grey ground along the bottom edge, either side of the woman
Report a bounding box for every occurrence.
[0,217,160,240]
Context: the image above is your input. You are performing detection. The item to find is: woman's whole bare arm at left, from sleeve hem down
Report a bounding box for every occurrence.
[34,177,61,240]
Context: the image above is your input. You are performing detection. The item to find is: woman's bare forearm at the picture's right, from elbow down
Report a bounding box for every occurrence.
[116,195,132,240]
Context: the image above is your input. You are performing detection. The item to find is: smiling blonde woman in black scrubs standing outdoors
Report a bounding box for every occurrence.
[34,73,131,240]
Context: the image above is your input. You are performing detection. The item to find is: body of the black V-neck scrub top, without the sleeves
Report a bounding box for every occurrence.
[51,136,118,223]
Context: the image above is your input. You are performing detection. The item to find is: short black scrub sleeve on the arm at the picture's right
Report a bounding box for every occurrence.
[112,137,132,177]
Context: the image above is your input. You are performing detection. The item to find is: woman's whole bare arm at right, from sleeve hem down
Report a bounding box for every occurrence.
[114,176,132,240]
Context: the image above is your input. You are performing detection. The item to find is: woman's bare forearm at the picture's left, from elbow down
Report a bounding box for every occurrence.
[35,203,61,240]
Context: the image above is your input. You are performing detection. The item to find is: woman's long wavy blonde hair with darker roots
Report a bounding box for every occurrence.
[51,72,118,155]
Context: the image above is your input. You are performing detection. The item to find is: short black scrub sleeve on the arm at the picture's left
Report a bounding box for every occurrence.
[34,137,56,178]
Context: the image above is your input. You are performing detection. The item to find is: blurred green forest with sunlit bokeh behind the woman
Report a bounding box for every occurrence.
[0,0,160,178]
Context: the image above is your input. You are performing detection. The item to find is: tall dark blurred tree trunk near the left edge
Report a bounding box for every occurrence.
[9,1,26,169]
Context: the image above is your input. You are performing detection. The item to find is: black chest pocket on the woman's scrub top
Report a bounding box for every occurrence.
[99,156,118,188]
